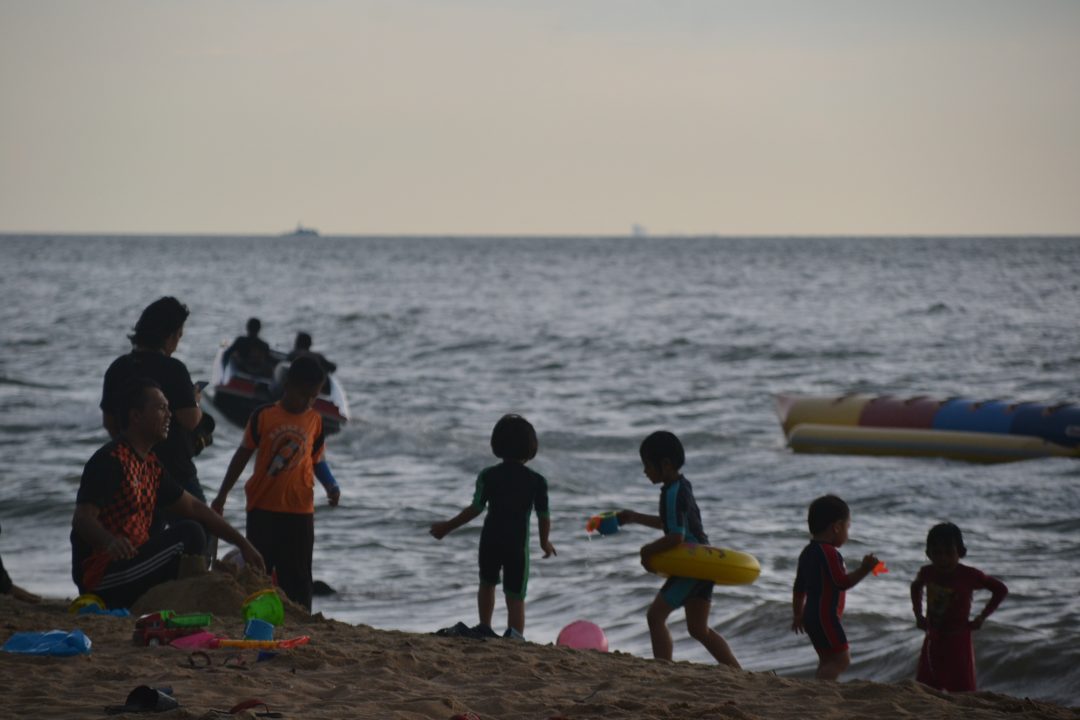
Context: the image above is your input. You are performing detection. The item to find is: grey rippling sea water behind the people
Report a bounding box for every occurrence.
[0,235,1080,705]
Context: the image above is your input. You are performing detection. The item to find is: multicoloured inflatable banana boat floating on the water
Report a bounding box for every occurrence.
[775,395,1080,463]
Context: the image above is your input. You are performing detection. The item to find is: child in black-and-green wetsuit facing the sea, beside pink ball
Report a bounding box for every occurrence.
[431,415,556,635]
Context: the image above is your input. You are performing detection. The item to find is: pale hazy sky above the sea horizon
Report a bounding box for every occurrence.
[0,0,1080,235]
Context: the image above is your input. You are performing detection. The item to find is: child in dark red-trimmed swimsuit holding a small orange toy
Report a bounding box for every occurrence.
[792,495,878,680]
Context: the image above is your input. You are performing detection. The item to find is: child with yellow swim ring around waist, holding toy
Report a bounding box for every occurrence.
[617,431,741,669]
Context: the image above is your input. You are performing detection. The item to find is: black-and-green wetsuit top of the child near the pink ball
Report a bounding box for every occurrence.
[472,462,551,547]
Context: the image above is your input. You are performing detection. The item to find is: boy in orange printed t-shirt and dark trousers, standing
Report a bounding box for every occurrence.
[211,357,341,610]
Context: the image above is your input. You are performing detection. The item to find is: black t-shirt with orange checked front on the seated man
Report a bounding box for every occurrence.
[71,438,184,579]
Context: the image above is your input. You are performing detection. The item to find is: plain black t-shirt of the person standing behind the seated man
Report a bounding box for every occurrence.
[100,350,197,483]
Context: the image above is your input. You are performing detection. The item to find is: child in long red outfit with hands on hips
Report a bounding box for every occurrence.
[912,522,1009,692]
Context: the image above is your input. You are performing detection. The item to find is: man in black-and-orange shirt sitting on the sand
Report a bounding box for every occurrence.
[71,378,265,608]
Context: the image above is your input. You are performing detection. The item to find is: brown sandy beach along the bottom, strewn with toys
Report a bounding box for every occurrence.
[0,573,1080,720]
